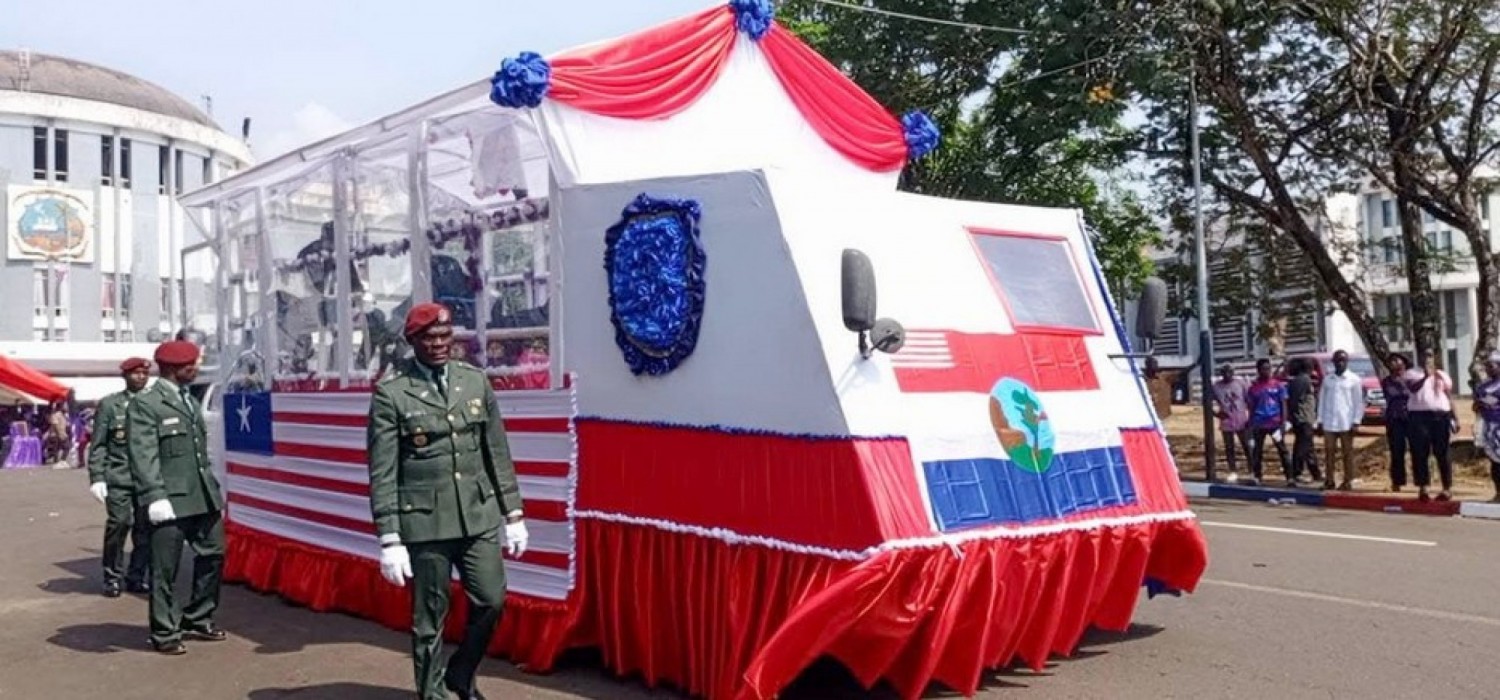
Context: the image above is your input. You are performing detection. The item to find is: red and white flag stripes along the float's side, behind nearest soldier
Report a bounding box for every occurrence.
[225,387,578,600]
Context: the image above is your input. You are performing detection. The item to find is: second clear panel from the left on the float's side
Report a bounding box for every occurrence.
[264,162,339,388]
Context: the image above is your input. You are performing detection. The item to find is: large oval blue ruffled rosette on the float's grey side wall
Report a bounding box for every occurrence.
[605,193,708,376]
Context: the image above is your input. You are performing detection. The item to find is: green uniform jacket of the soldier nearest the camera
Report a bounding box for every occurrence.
[368,360,522,543]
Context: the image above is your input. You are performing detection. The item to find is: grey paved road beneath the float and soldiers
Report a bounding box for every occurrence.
[0,471,1500,700]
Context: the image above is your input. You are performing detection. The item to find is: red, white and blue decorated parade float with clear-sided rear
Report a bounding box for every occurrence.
[183,0,1206,699]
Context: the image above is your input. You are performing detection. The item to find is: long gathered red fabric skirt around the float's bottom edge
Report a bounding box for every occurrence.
[225,520,1206,700]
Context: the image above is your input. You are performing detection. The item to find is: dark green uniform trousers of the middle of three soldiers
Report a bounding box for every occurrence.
[150,511,224,646]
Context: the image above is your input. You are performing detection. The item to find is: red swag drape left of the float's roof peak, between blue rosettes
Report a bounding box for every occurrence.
[548,7,737,120]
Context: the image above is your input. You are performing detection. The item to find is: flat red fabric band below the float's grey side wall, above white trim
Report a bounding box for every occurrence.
[576,420,930,552]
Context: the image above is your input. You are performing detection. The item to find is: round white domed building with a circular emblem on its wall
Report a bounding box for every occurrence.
[0,51,251,400]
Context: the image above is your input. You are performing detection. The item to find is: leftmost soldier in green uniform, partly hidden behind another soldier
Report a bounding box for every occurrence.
[89,357,152,598]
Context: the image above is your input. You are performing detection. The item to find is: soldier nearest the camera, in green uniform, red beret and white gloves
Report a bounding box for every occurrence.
[368,304,528,700]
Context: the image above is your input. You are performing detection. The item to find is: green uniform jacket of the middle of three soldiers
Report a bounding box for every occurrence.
[126,381,224,517]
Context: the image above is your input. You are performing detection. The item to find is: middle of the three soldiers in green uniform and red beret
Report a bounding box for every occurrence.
[126,340,225,655]
